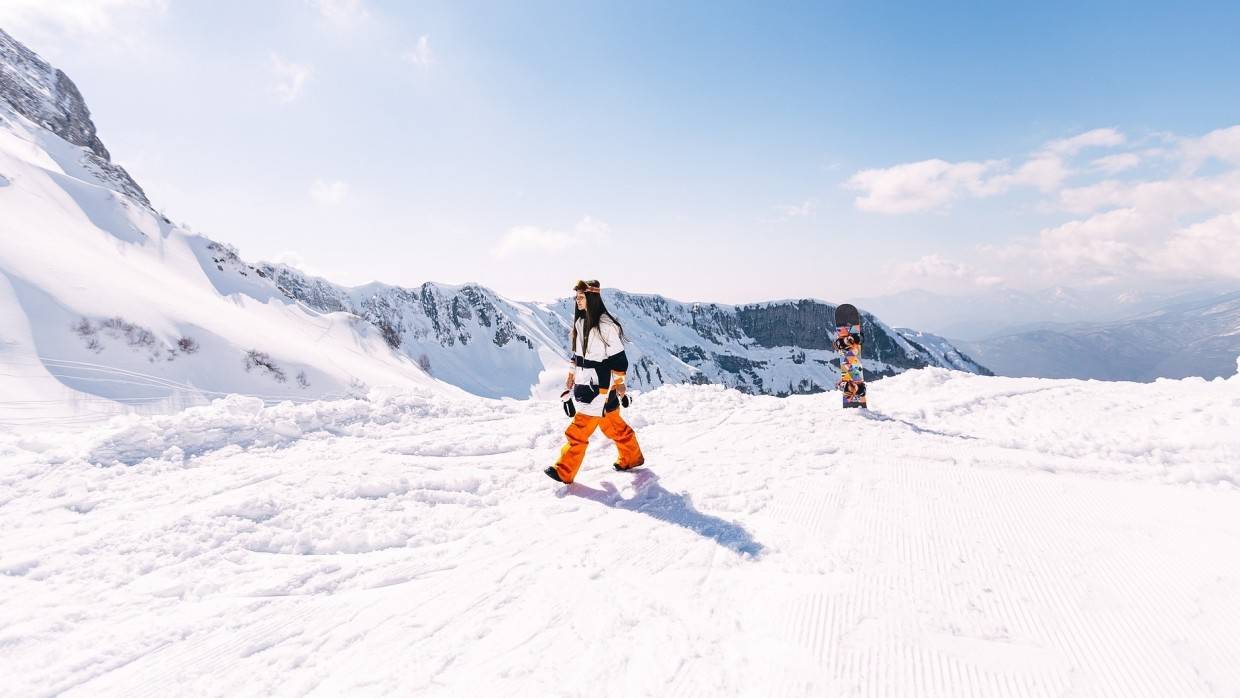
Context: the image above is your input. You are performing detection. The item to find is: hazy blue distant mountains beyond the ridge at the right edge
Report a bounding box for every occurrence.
[956,293,1240,381]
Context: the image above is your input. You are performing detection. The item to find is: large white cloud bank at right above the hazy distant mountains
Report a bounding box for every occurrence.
[849,126,1240,289]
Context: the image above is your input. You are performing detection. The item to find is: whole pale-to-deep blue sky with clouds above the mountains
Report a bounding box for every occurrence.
[0,0,1240,303]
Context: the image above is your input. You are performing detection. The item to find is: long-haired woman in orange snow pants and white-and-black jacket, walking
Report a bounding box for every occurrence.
[543,281,646,484]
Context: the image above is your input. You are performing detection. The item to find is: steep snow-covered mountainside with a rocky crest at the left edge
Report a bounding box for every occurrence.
[0,28,443,424]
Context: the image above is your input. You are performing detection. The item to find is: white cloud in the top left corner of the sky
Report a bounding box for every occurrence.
[0,0,167,41]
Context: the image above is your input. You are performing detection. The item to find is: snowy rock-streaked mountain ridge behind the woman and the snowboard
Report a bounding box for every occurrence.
[227,246,988,398]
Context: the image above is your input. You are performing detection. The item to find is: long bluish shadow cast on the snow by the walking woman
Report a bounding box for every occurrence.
[557,469,763,558]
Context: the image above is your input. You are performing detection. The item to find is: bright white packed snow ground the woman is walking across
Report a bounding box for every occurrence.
[0,369,1240,698]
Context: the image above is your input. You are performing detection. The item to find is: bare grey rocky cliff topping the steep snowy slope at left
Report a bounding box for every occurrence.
[0,30,150,207]
